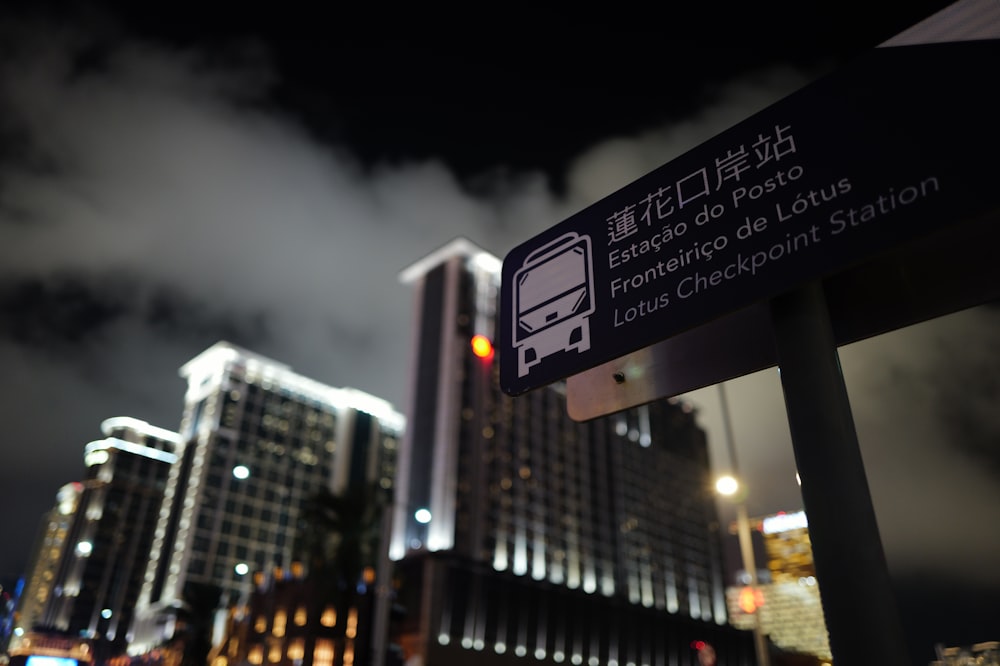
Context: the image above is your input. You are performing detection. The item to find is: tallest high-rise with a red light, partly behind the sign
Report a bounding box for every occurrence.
[390,239,753,666]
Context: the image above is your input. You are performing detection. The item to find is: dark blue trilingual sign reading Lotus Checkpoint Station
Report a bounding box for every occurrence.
[499,39,1000,395]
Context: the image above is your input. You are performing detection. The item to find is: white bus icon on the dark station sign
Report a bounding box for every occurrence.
[513,231,594,377]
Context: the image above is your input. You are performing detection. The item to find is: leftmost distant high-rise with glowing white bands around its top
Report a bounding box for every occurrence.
[11,417,179,656]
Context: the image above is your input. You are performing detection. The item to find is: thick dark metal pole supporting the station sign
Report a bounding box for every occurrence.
[770,282,912,666]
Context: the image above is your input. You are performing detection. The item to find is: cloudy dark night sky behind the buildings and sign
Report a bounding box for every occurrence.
[0,1,1000,663]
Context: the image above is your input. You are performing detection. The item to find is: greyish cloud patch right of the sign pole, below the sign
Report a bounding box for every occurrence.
[842,306,1000,587]
